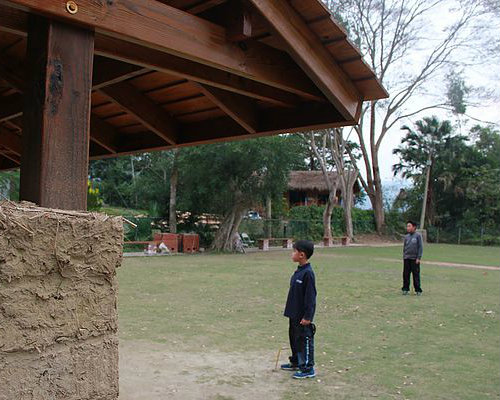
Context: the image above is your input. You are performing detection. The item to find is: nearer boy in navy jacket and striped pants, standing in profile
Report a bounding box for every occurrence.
[281,240,316,379]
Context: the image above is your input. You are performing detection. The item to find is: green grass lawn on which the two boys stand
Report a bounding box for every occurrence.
[118,245,500,400]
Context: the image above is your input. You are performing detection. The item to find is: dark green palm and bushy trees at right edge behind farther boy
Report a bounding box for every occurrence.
[394,117,500,229]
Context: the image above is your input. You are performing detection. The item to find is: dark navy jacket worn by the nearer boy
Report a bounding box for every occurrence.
[284,263,316,321]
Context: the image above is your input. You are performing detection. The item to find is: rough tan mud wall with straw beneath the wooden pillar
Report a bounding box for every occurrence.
[0,202,123,400]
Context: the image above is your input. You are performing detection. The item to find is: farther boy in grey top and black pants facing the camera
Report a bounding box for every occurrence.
[402,221,423,296]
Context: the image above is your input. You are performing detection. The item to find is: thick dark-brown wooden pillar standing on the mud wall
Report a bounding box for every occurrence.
[20,16,94,210]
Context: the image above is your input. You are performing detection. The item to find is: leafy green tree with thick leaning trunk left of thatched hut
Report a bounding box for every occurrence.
[180,136,304,251]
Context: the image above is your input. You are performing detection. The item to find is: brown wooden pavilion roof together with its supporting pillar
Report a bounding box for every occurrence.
[0,0,387,209]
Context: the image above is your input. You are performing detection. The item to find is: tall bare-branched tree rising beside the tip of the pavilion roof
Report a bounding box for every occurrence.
[323,0,490,233]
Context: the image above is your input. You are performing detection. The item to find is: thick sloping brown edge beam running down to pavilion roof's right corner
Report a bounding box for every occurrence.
[250,0,362,121]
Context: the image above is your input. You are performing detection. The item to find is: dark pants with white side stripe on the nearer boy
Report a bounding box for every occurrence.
[288,318,315,371]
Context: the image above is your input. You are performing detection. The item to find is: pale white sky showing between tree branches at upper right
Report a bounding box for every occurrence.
[359,0,500,186]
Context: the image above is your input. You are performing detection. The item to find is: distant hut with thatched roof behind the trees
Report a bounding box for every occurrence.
[286,171,360,207]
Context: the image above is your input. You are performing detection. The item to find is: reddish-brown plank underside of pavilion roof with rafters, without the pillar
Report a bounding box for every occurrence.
[0,0,387,169]
